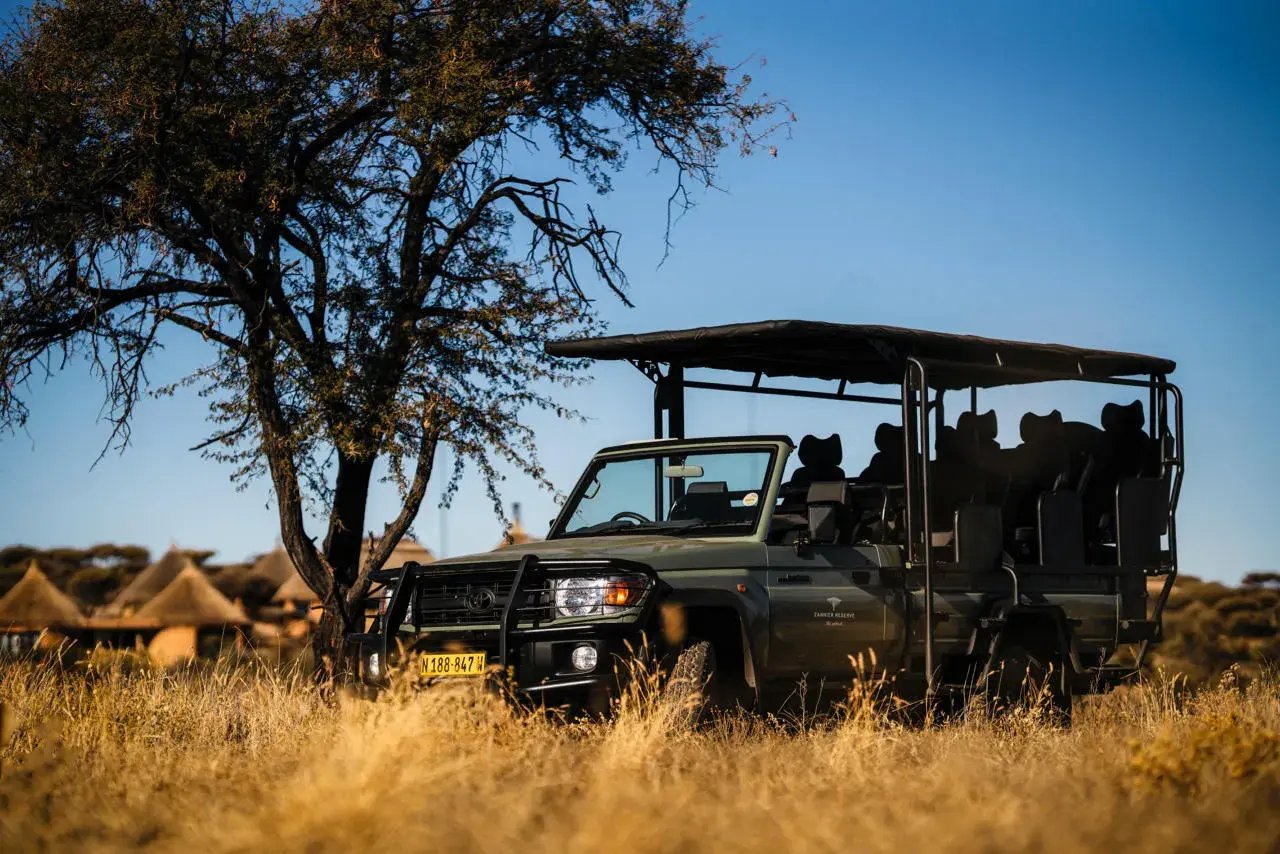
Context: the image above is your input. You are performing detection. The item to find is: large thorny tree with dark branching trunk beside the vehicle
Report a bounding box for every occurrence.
[0,0,777,666]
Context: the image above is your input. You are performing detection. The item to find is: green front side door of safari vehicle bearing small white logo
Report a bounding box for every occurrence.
[765,545,904,681]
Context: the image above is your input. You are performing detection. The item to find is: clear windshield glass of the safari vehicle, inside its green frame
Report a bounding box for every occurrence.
[557,448,774,536]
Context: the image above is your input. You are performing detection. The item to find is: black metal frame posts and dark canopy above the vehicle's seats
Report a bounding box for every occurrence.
[547,320,1185,690]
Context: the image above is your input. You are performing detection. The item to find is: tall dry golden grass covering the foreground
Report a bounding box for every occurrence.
[0,662,1280,851]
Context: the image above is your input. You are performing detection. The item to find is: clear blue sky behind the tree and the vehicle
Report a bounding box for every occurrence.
[0,0,1280,579]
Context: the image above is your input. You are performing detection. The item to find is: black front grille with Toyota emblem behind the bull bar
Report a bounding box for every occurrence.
[413,568,552,627]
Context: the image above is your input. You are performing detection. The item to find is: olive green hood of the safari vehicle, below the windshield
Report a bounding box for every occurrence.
[419,534,765,571]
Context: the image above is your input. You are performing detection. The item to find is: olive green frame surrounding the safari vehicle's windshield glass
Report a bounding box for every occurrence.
[547,437,792,540]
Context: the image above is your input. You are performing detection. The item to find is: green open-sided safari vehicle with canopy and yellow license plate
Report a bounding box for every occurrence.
[353,320,1183,716]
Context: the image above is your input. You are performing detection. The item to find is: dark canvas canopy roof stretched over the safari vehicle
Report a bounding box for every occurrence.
[547,320,1175,388]
